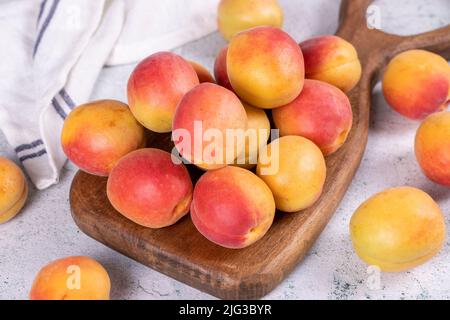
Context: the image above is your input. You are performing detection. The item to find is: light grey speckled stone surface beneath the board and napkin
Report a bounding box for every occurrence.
[0,0,450,299]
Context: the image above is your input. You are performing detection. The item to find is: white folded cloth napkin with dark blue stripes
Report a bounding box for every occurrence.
[0,0,218,189]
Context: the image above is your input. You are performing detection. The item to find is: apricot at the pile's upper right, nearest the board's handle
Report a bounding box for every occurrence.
[300,35,362,93]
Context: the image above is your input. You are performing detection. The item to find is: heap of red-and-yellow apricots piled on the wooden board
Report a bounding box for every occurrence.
[62,23,361,249]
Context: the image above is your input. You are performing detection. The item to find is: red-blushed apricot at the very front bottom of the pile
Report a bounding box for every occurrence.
[191,167,275,249]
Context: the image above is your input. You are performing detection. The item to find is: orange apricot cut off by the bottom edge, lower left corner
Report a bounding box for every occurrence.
[30,257,111,300]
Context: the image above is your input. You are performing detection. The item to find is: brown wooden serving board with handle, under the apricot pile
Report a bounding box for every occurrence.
[70,0,450,299]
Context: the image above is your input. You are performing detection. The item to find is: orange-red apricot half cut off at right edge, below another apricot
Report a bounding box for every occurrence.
[415,112,450,187]
